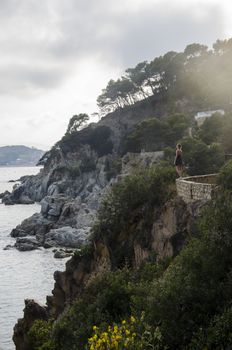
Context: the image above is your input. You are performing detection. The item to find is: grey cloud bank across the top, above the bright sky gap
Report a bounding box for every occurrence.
[0,0,227,96]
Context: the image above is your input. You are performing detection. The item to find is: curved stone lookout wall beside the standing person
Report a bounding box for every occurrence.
[176,174,217,203]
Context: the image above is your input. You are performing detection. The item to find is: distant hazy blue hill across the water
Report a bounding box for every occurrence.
[0,145,44,166]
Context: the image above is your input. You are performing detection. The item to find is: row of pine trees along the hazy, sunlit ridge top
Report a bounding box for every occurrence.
[97,39,232,114]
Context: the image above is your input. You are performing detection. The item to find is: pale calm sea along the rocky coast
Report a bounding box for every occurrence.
[0,167,67,350]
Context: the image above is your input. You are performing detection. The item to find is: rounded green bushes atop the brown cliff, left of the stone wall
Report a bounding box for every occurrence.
[93,166,175,266]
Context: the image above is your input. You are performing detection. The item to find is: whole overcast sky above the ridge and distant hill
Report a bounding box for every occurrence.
[0,0,232,150]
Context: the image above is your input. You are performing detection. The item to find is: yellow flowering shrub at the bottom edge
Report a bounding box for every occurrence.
[87,315,167,350]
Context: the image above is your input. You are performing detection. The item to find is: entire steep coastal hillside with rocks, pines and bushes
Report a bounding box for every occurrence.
[9,40,232,350]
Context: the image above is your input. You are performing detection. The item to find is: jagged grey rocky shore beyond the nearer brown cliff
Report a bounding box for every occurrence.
[2,147,163,258]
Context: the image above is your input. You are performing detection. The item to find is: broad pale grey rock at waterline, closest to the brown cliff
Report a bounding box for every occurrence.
[44,226,88,248]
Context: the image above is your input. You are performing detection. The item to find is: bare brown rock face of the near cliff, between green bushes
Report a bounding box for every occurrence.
[14,197,204,350]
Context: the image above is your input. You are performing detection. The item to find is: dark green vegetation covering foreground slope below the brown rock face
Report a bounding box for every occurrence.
[27,164,232,350]
